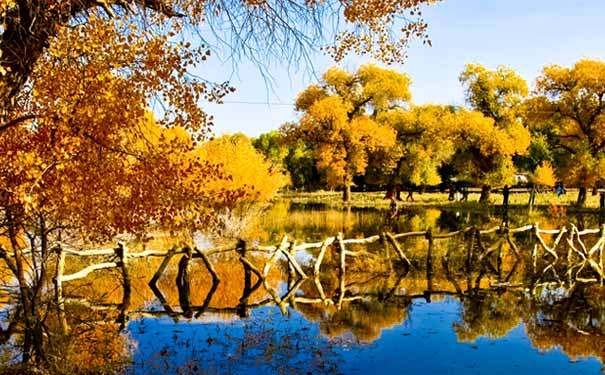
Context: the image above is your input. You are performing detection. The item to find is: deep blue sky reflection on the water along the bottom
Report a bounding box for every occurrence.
[128,298,601,374]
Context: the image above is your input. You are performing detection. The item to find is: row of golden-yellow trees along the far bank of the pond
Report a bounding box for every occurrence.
[254,60,605,206]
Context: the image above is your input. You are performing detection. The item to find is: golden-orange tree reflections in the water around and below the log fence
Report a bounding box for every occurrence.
[0,215,605,374]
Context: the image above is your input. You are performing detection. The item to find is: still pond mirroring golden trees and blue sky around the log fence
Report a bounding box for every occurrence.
[3,201,605,374]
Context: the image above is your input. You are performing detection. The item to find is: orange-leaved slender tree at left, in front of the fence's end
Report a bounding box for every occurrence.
[0,17,244,361]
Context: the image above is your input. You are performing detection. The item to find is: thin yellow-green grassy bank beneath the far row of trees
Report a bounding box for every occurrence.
[280,189,599,212]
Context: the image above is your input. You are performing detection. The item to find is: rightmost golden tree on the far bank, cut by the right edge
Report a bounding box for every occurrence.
[526,60,605,206]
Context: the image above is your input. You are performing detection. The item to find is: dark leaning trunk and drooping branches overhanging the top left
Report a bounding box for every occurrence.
[0,0,434,127]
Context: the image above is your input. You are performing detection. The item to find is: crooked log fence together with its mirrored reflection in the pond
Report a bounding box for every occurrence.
[54,224,605,329]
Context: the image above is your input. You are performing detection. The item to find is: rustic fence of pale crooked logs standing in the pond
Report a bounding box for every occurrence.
[41,223,605,327]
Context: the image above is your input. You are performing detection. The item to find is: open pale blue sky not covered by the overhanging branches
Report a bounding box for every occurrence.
[203,0,605,136]
